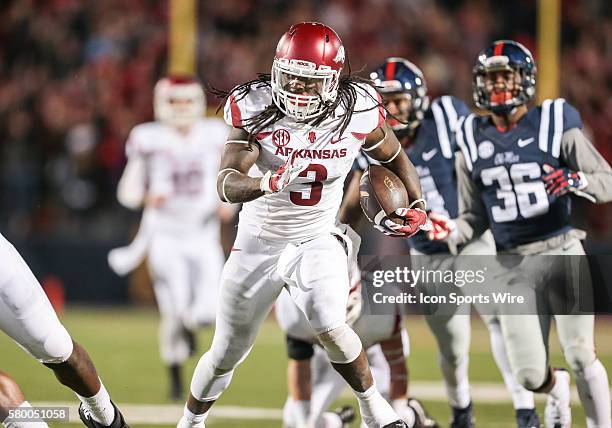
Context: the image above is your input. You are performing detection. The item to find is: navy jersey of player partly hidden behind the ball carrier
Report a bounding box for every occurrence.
[353,96,470,254]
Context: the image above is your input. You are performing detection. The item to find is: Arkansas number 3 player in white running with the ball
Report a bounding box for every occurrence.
[179,23,427,427]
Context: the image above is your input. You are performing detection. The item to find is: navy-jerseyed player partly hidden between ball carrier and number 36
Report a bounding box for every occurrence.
[339,58,539,428]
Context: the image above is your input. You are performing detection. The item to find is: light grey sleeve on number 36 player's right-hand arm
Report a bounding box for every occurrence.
[561,128,612,203]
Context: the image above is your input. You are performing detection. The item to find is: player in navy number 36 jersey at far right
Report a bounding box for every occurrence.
[430,40,612,428]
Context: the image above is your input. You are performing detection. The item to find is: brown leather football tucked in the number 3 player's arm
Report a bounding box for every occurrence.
[359,165,409,226]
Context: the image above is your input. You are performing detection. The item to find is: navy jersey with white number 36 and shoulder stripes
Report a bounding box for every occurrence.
[457,99,582,250]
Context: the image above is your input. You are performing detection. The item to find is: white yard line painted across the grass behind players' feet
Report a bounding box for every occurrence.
[33,381,608,424]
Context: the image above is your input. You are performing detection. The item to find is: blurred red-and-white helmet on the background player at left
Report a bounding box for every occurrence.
[153,76,206,127]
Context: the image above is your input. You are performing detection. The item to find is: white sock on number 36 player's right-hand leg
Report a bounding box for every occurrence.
[575,360,612,428]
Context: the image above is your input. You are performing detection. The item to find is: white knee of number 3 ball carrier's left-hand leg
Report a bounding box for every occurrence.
[190,352,234,401]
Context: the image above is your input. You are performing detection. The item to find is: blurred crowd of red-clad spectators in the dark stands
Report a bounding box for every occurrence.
[0,0,612,240]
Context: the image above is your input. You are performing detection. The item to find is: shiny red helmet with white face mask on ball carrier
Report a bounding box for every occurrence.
[272,22,344,120]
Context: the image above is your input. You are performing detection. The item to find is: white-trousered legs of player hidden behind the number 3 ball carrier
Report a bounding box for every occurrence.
[274,254,438,428]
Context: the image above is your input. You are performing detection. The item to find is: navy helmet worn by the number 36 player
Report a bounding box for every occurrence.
[472,40,537,115]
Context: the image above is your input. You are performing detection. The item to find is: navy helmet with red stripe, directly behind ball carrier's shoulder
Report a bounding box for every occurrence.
[370,58,429,137]
